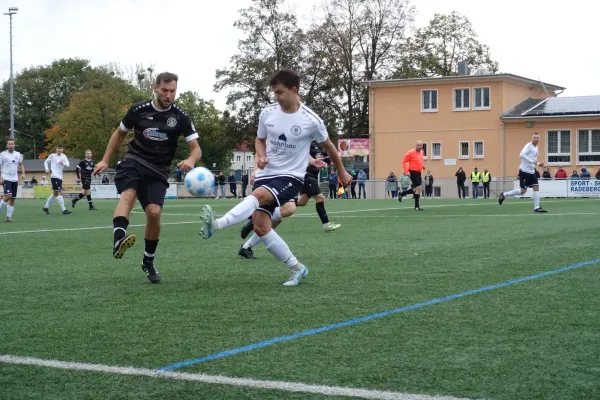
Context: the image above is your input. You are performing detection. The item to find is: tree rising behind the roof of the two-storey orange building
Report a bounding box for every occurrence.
[393,11,498,78]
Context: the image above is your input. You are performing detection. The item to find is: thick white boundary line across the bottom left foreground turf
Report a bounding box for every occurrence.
[0,355,476,400]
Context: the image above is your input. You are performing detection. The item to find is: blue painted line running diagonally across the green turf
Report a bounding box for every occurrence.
[157,258,600,371]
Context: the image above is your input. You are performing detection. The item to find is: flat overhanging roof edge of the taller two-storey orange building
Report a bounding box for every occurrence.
[360,74,565,91]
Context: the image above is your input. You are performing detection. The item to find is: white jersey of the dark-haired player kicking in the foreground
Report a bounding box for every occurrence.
[256,104,328,180]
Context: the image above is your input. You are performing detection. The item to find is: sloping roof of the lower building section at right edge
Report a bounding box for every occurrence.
[502,96,600,119]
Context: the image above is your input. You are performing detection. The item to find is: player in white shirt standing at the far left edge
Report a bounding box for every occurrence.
[0,139,25,222]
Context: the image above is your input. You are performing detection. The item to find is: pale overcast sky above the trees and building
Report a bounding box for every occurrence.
[0,0,600,109]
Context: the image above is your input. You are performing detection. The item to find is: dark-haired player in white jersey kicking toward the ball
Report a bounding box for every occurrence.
[201,69,352,286]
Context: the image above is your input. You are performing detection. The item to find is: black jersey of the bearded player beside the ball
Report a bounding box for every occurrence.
[121,101,198,174]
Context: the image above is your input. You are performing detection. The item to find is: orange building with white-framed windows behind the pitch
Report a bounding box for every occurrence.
[365,74,600,179]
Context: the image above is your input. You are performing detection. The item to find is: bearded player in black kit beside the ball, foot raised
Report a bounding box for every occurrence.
[93,72,202,283]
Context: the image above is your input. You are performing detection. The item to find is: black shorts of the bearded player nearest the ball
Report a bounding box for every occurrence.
[115,158,169,209]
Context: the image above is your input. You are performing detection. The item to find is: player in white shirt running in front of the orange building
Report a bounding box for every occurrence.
[498,133,547,213]
